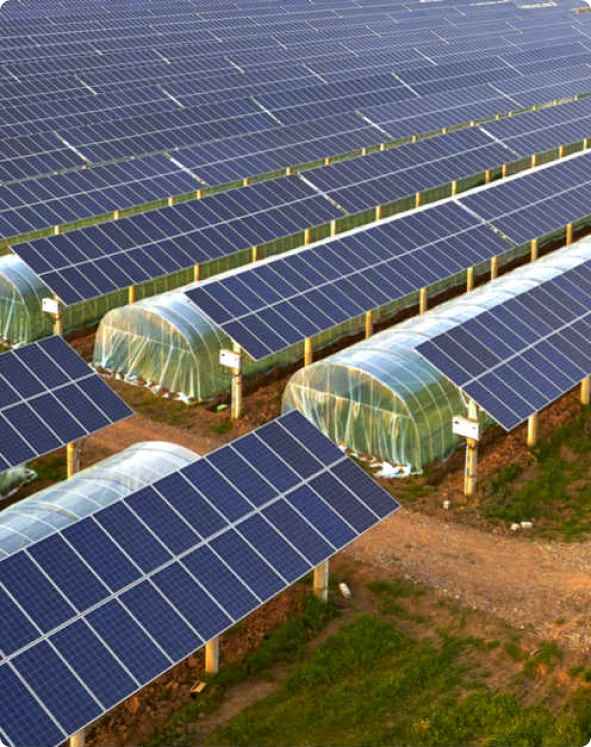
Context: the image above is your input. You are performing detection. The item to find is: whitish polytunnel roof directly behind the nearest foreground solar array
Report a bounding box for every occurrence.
[0,441,198,559]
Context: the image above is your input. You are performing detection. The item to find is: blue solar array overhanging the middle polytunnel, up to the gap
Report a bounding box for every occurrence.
[186,202,509,360]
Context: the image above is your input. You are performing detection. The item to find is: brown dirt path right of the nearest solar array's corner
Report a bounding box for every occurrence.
[344,509,591,649]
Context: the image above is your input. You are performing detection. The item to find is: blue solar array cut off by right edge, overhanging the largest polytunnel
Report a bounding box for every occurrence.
[417,260,591,430]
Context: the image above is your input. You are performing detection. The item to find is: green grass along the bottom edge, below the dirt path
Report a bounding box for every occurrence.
[207,615,591,747]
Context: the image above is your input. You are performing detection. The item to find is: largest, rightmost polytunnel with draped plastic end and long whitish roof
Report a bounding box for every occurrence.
[283,239,591,474]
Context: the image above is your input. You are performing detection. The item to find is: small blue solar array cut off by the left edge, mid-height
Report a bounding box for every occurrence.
[0,337,133,472]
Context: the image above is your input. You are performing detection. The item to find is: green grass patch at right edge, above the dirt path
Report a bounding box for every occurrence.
[481,407,591,540]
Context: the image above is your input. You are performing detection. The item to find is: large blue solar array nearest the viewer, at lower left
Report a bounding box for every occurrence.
[0,412,399,745]
